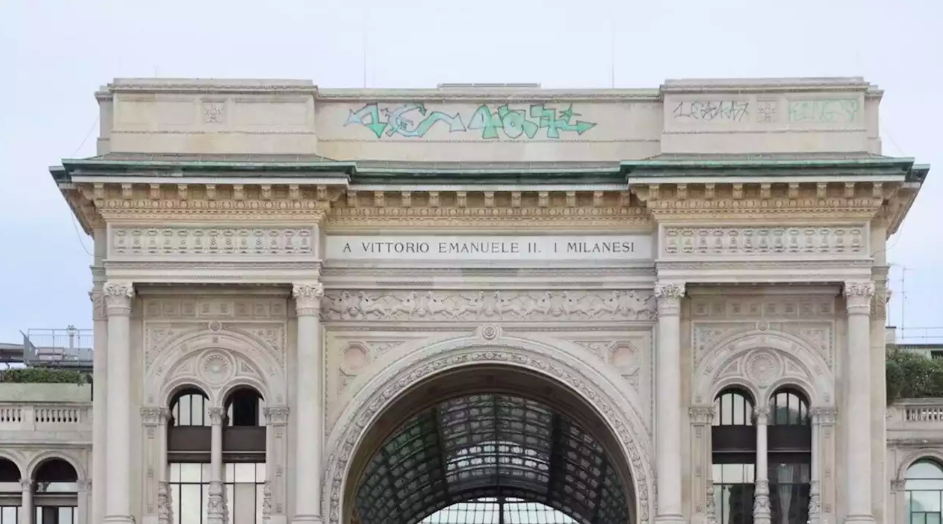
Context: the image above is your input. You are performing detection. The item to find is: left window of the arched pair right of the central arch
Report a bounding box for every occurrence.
[711,389,756,524]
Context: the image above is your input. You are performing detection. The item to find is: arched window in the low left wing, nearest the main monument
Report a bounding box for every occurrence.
[33,458,79,524]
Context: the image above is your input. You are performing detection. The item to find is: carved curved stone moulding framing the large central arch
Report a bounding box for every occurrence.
[322,326,654,524]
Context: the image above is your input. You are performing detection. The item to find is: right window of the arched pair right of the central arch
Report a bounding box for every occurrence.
[767,387,812,524]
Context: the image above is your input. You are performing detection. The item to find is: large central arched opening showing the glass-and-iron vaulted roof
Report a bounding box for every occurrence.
[343,364,636,524]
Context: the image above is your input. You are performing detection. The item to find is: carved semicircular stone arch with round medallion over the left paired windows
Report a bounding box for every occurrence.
[144,325,287,407]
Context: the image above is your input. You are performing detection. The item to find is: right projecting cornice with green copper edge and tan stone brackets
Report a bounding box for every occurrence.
[622,155,929,235]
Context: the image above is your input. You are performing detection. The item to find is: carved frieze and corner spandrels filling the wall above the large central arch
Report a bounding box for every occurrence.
[321,289,656,434]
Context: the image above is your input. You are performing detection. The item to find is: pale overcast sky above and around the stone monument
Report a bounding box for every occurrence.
[0,0,943,342]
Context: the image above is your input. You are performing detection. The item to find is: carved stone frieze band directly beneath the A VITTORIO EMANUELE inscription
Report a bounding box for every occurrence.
[321,290,656,321]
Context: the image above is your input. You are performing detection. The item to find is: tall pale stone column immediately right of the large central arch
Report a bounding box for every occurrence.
[655,283,684,523]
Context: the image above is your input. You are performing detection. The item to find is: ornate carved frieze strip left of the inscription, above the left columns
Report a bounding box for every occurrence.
[108,226,317,256]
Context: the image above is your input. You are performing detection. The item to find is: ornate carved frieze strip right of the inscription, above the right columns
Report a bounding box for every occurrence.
[662,225,868,256]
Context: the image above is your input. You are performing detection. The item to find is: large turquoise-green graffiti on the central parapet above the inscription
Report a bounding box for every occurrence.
[344,102,596,140]
